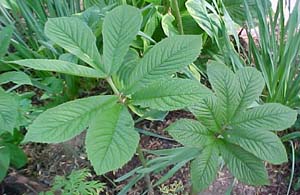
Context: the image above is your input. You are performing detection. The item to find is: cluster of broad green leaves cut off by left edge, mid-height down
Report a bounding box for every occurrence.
[0,76,31,181]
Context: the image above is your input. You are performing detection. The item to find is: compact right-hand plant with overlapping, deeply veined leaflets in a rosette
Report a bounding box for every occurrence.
[167,62,297,192]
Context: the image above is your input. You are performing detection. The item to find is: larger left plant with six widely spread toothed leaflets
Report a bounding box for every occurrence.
[11,5,209,181]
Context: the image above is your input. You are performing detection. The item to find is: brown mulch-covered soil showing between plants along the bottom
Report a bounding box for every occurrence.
[0,111,300,195]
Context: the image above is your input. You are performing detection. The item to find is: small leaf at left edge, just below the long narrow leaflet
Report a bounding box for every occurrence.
[0,71,32,85]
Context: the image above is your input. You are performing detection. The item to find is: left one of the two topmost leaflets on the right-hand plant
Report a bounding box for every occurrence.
[207,62,238,122]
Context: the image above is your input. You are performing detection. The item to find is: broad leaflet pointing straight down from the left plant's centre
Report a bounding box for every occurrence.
[86,104,139,175]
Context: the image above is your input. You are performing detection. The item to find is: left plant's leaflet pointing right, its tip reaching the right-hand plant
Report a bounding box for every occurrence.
[132,79,212,111]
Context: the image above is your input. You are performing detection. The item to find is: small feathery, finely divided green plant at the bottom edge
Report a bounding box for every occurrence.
[41,169,104,195]
